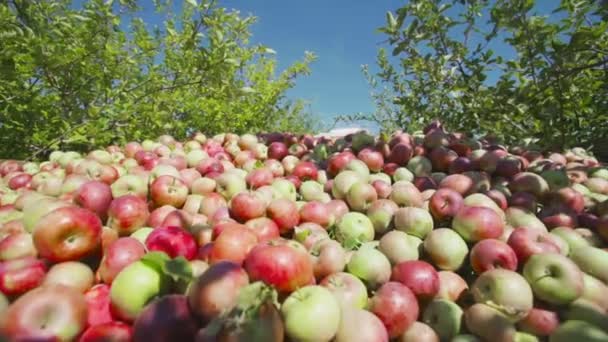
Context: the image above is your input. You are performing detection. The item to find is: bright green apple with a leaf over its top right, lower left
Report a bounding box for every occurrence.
[110,259,169,322]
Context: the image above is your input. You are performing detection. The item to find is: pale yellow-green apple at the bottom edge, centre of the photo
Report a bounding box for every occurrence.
[281,285,340,341]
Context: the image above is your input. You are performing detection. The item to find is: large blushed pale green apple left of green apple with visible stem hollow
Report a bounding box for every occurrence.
[471,268,534,322]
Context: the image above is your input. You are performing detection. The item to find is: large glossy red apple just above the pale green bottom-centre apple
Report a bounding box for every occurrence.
[244,239,314,293]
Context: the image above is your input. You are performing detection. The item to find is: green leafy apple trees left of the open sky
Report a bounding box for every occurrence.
[0,0,315,158]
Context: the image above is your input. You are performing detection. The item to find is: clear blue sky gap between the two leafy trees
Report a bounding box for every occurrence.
[219,0,403,128]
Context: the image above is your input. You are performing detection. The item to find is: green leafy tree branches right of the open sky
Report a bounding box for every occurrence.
[351,0,608,151]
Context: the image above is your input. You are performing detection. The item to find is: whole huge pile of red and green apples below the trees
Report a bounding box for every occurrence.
[0,122,608,342]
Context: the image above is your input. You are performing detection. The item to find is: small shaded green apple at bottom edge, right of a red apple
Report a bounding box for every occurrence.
[422,299,463,341]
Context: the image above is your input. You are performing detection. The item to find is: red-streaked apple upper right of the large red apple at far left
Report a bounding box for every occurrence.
[107,195,150,236]
